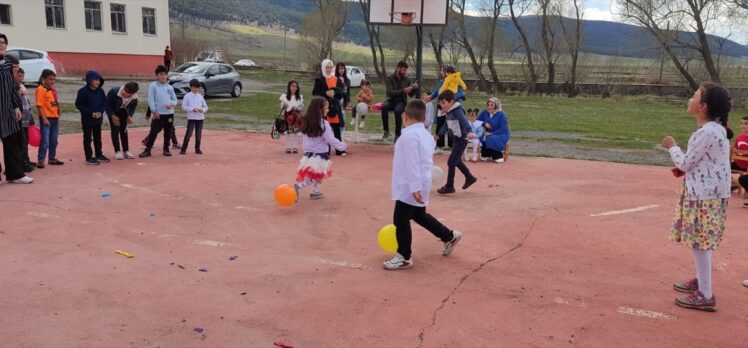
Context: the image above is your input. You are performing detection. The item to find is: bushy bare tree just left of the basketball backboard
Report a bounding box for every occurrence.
[302,0,348,66]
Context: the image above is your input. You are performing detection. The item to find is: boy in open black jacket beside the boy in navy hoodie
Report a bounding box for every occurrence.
[106,82,140,160]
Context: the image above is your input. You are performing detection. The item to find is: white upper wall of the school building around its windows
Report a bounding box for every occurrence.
[0,0,170,55]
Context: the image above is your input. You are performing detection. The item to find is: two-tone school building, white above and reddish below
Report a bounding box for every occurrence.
[0,0,170,76]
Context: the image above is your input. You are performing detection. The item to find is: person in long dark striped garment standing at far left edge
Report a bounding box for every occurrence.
[0,34,34,184]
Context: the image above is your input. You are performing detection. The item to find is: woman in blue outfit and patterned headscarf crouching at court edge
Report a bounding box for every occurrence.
[478,97,510,163]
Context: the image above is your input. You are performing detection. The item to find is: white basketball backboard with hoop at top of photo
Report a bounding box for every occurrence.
[367,0,449,26]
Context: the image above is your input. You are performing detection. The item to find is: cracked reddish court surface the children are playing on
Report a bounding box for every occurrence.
[0,129,748,347]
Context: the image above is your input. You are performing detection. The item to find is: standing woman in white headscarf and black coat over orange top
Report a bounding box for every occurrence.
[312,59,346,156]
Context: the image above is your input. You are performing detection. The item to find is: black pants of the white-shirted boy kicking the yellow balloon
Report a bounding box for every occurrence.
[393,201,454,259]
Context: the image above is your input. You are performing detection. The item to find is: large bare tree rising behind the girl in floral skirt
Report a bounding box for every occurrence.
[618,0,725,90]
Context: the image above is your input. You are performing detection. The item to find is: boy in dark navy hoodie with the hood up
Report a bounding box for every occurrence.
[75,71,109,165]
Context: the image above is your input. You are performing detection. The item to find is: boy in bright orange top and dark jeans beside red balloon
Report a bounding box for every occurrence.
[36,69,65,169]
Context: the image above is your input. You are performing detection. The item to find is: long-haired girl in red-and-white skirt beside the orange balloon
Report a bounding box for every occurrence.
[294,97,348,199]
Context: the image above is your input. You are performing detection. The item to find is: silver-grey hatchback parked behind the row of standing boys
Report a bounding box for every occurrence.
[169,62,242,98]
